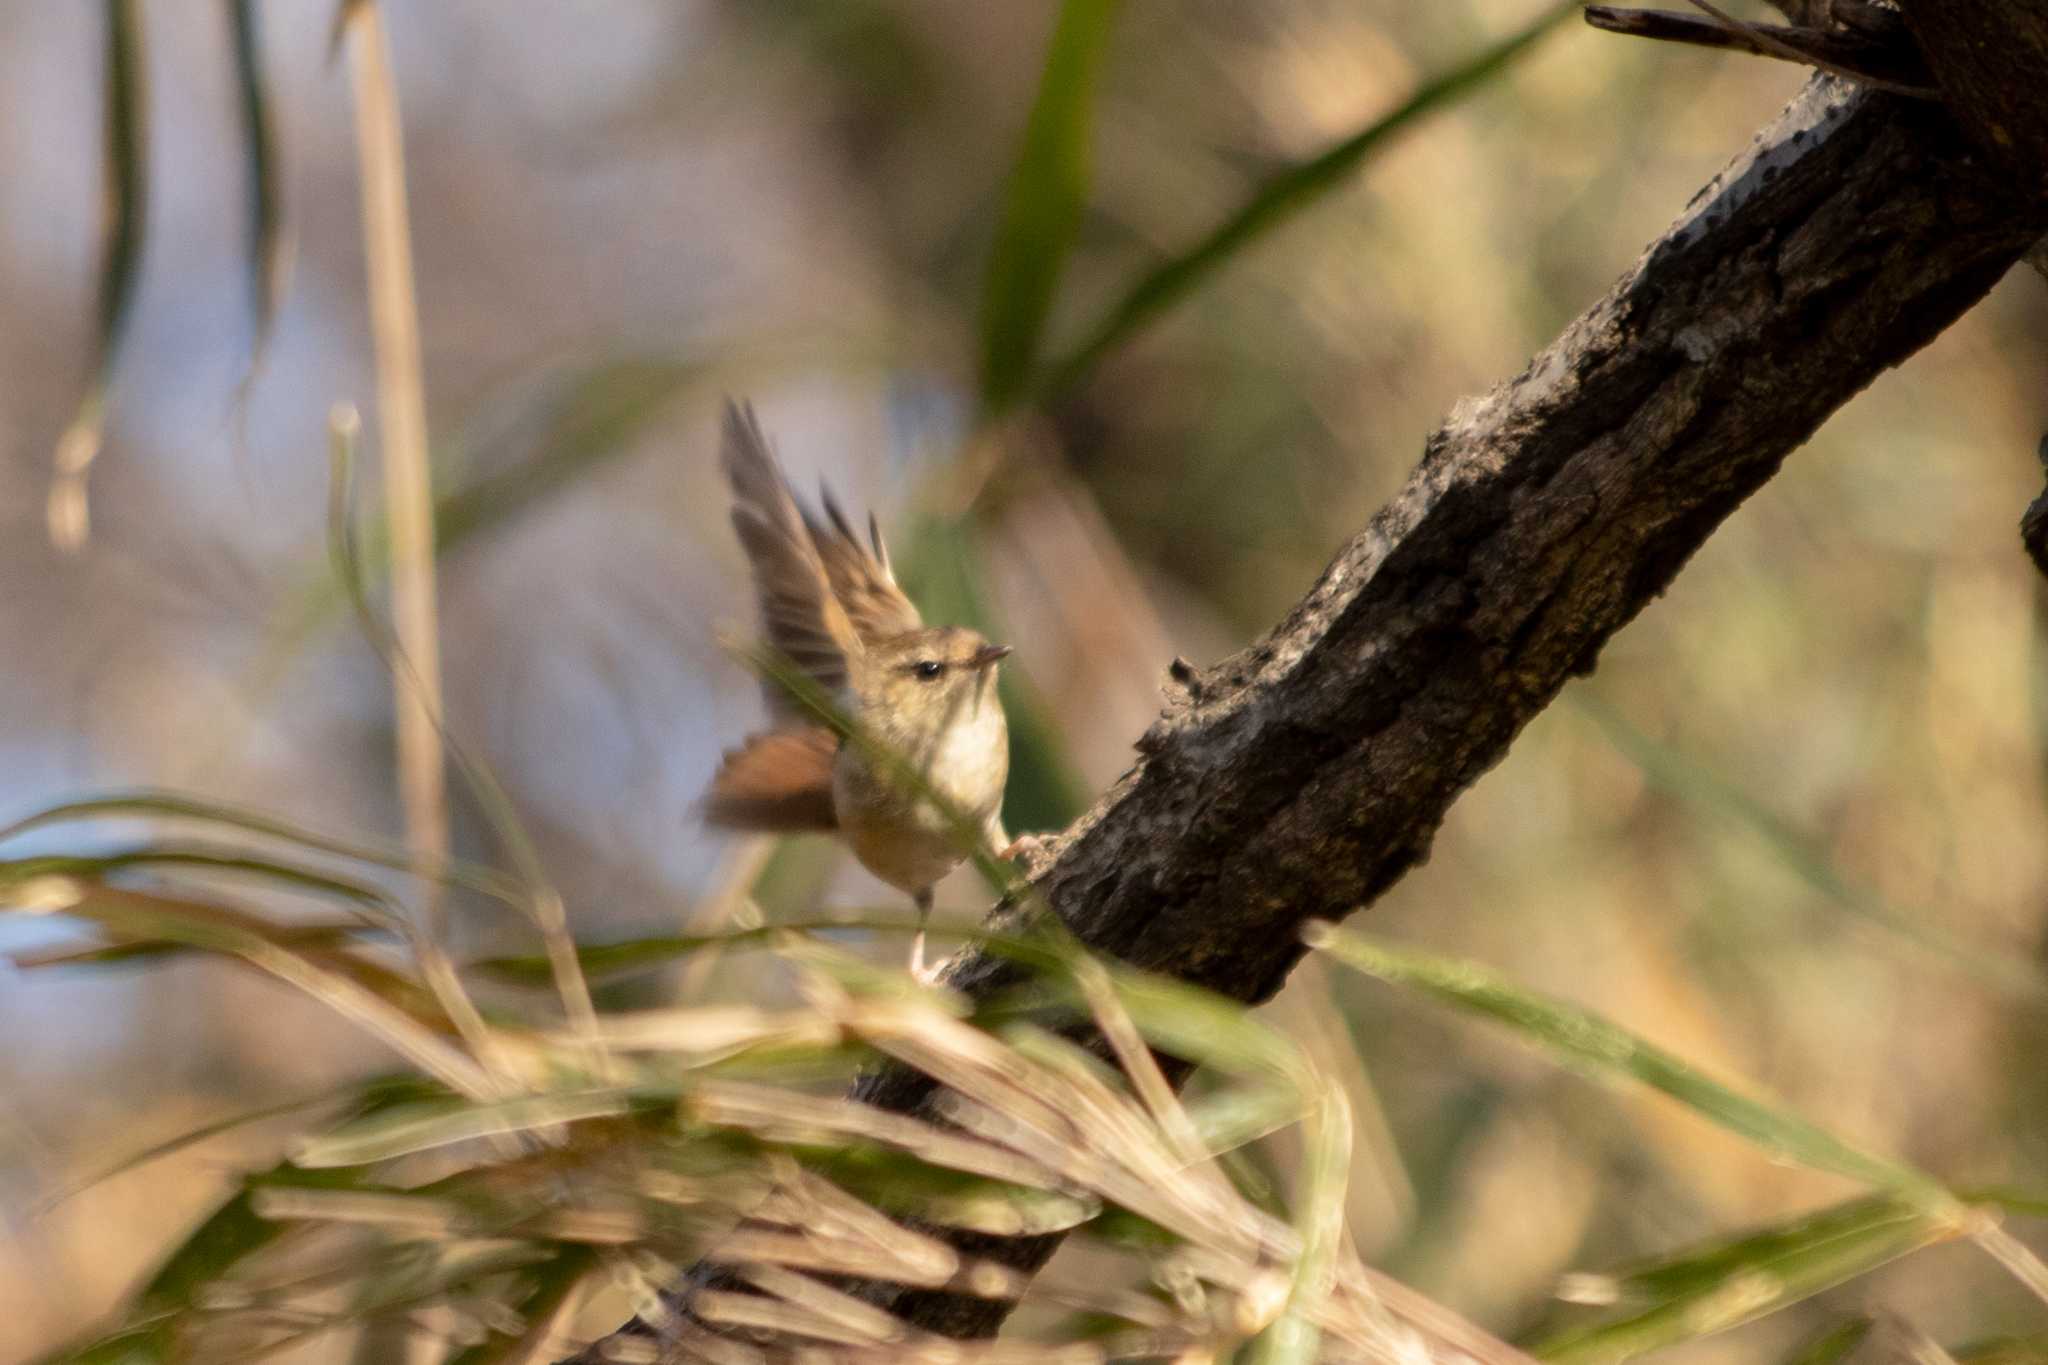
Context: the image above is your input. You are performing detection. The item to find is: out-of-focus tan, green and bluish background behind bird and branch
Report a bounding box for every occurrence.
[0,0,2048,1361]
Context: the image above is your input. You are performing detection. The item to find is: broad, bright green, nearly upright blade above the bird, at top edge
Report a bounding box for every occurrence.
[981,0,1116,411]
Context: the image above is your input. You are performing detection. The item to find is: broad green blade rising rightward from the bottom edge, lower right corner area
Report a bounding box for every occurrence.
[1534,1195,1962,1365]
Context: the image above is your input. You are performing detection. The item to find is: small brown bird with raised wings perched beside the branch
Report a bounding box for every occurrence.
[705,403,1010,976]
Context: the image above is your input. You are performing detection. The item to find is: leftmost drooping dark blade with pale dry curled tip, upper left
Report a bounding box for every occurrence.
[45,0,150,551]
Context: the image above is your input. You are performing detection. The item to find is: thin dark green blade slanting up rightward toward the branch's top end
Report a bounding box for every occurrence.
[1040,0,1581,397]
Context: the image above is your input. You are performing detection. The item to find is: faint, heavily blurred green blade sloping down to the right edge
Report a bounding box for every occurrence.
[1573,692,2048,1001]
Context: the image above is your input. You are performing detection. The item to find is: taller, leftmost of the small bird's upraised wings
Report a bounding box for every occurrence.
[723,403,862,718]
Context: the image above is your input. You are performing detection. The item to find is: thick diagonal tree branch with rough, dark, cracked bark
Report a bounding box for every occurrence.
[580,0,2048,1363]
